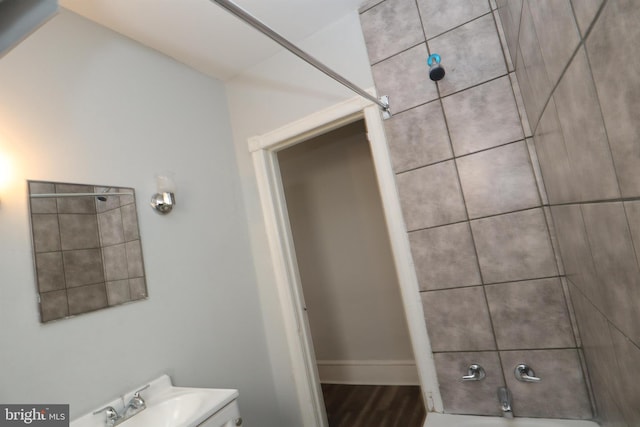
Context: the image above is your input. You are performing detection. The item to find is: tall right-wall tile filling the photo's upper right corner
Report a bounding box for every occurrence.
[587,0,640,197]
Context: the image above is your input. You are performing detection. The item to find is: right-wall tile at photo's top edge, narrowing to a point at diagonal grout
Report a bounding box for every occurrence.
[528,0,580,84]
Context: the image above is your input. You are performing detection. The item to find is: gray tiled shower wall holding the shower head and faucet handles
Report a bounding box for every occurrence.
[360,0,592,418]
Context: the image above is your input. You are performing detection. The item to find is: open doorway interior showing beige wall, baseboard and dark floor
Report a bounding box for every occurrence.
[277,119,425,427]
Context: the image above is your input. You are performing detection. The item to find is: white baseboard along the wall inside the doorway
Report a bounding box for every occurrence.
[317,360,420,385]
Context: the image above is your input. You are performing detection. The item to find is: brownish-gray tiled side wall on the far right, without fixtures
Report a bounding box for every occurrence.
[498,0,640,427]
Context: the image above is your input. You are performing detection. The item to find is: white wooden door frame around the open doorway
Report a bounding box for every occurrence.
[248,90,443,427]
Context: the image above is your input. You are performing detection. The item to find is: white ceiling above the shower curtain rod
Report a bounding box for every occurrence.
[59,0,362,80]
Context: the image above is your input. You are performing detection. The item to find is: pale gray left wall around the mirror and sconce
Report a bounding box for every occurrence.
[0,11,283,426]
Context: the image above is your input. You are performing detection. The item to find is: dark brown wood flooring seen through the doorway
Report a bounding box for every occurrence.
[322,384,426,427]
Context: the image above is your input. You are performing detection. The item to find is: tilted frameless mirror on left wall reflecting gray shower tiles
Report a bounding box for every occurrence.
[28,181,147,323]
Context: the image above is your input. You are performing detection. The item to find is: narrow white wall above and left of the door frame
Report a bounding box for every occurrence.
[226,11,373,426]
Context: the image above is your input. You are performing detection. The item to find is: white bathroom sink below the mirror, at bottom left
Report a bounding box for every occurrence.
[71,375,239,427]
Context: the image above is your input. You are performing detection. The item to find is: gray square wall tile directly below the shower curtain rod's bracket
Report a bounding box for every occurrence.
[384,101,453,173]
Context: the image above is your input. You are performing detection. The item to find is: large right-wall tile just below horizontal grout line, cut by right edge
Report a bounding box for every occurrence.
[582,202,640,342]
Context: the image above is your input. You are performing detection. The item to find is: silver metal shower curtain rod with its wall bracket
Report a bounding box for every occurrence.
[211,0,391,119]
